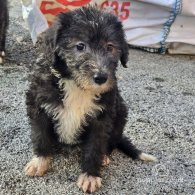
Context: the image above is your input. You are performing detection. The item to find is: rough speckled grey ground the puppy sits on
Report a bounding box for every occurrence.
[0,0,195,195]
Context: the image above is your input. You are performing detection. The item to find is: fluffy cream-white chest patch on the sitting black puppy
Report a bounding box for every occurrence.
[44,81,103,144]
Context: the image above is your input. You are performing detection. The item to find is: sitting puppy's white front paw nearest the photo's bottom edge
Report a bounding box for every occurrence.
[77,173,102,193]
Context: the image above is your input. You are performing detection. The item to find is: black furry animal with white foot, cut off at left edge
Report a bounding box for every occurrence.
[0,0,9,64]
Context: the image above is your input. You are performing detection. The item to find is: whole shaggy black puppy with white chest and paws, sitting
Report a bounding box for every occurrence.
[25,7,156,192]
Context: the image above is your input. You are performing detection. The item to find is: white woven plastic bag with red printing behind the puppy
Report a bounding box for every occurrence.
[23,0,195,54]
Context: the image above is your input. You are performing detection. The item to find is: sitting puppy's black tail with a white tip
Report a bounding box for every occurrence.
[117,135,157,162]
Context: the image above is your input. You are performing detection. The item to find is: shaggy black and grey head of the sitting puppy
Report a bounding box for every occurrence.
[49,7,128,93]
